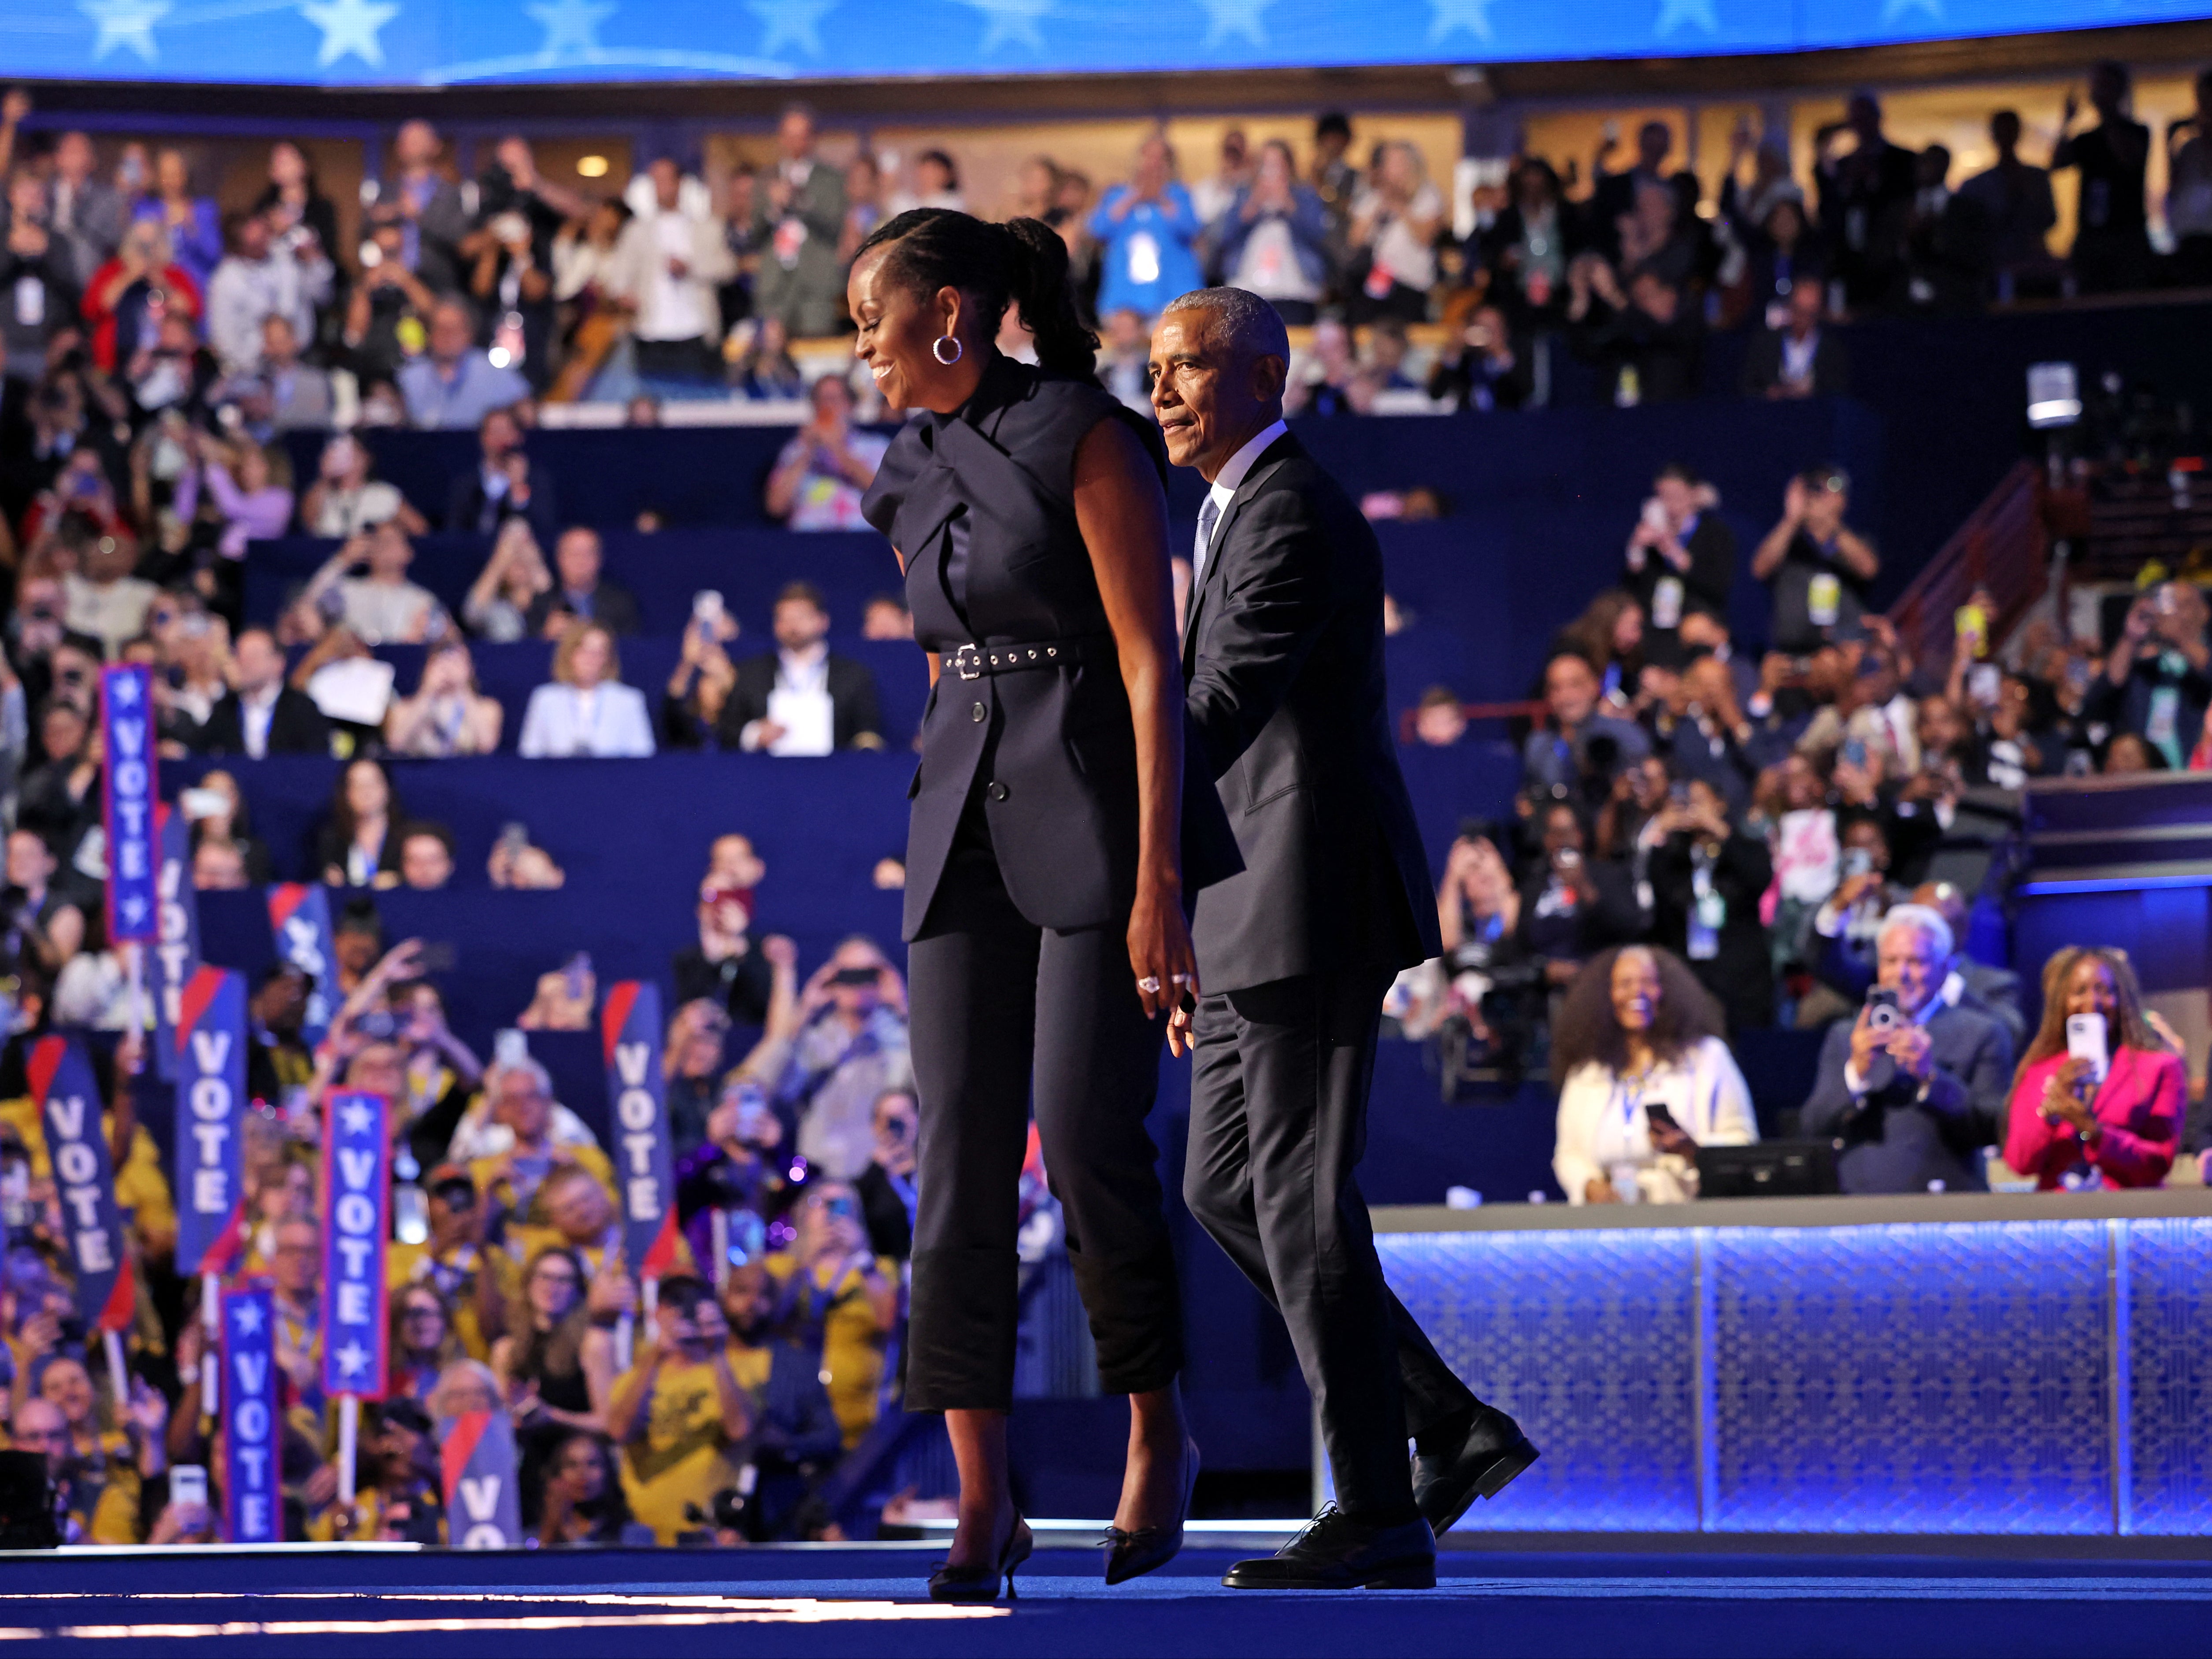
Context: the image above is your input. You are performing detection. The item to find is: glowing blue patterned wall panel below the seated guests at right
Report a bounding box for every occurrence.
[1378,1219,2212,1535]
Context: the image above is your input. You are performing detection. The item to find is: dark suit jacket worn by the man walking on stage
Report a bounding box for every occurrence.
[1183,436,1442,991]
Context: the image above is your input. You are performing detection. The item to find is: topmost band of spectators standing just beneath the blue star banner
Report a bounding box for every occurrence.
[0,62,2212,442]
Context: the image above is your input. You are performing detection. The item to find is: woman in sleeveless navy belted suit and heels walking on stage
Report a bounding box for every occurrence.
[847,208,1237,1599]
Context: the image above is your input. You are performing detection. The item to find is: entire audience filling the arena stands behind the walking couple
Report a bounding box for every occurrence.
[0,67,2212,1546]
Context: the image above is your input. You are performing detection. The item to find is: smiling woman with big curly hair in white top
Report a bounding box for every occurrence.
[1551,944,1759,1204]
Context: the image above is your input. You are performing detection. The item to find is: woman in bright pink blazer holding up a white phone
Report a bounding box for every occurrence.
[2004,947,2190,1190]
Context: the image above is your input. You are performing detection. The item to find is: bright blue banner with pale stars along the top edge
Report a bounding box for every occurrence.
[0,0,2203,86]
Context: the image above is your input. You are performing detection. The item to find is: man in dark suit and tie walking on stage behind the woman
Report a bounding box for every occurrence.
[1150,288,1535,1588]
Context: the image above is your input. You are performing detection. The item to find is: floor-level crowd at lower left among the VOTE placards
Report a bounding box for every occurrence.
[0,814,960,1546]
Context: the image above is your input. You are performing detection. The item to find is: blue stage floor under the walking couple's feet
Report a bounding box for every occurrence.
[0,1540,2212,1659]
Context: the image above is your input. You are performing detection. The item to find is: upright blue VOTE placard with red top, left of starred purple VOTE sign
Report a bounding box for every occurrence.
[170,967,245,1276]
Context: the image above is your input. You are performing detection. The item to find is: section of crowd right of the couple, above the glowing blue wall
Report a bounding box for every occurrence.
[1393,449,2212,1204]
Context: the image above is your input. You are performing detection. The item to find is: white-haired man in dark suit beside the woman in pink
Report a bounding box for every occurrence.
[1798,905,2013,1192]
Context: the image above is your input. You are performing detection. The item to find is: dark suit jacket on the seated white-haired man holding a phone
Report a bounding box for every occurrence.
[1801,1007,2013,1192]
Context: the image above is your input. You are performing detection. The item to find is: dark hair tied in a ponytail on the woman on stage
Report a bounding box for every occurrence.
[854,208,1099,381]
